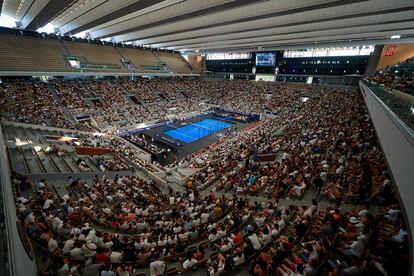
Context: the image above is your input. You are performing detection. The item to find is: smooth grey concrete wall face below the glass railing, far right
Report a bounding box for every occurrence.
[360,82,414,275]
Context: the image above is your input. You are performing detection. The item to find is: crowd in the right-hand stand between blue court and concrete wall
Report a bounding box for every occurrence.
[187,87,390,206]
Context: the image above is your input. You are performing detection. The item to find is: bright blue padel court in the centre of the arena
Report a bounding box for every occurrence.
[164,119,232,143]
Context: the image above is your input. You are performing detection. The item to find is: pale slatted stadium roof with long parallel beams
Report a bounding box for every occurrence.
[0,0,414,52]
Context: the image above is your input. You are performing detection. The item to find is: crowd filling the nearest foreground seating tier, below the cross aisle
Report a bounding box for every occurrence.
[12,170,410,275]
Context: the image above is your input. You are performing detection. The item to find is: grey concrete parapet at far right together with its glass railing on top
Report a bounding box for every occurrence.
[360,81,414,275]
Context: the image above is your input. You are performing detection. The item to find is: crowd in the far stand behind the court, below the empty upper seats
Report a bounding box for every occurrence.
[1,78,314,132]
